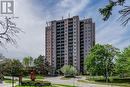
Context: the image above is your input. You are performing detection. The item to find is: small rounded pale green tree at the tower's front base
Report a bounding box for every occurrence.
[61,65,77,77]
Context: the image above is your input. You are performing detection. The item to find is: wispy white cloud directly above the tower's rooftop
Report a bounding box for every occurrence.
[57,0,90,15]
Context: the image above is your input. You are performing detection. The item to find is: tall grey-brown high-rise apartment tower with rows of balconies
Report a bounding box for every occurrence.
[45,16,95,72]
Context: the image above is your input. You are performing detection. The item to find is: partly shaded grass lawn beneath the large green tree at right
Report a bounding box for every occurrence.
[78,77,130,87]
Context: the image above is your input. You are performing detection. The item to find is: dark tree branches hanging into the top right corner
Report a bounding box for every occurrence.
[99,0,130,26]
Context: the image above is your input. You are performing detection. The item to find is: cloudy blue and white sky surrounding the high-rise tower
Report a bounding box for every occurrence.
[0,0,130,59]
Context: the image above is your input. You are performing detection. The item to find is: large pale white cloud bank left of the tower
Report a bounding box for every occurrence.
[0,0,44,58]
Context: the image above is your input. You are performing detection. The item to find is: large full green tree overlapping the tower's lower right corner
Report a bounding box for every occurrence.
[85,44,117,82]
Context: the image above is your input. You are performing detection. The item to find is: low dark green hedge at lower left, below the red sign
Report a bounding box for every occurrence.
[21,80,51,86]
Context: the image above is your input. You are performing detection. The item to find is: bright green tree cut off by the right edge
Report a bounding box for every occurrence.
[115,46,130,78]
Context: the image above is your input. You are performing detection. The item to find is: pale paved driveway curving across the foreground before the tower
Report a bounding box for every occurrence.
[45,77,119,87]
